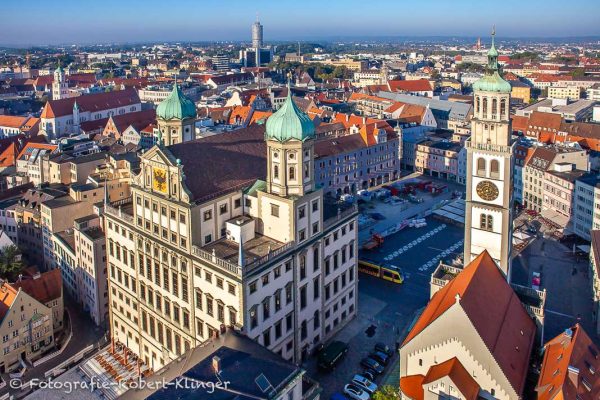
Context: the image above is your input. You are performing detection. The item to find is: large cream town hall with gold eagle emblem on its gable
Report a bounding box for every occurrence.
[105,92,357,369]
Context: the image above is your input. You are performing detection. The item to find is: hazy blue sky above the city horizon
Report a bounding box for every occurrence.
[0,0,600,45]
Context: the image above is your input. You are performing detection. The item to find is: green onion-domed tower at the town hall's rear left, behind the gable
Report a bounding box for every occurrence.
[156,82,197,146]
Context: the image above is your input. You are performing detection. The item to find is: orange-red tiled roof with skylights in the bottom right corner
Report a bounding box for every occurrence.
[536,324,600,400]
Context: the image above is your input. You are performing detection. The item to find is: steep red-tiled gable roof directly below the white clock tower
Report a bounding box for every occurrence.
[403,251,536,393]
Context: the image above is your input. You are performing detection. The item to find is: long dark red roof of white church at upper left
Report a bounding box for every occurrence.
[41,88,140,118]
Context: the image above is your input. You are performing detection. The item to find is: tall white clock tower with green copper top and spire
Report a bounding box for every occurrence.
[464,29,513,281]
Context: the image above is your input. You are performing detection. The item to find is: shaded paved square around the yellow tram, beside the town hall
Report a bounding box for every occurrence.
[304,183,464,399]
